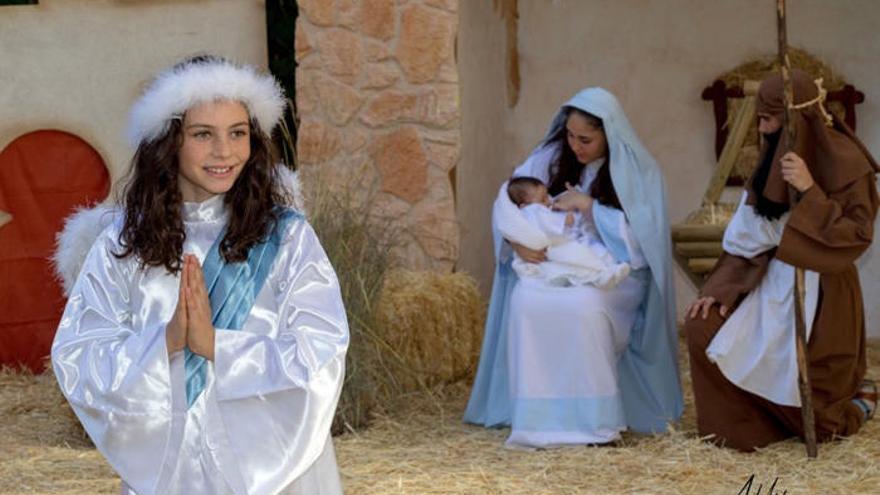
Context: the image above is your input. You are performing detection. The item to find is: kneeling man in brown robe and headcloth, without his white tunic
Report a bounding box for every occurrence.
[684,71,878,451]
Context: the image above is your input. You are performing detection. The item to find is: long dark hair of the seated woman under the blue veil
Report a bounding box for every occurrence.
[547,107,623,210]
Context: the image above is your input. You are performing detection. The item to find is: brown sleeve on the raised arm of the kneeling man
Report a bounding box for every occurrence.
[776,173,878,273]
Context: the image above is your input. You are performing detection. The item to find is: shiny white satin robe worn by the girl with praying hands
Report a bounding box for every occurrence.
[52,196,348,495]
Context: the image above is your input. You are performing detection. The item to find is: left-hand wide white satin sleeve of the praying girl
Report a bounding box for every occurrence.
[52,228,185,493]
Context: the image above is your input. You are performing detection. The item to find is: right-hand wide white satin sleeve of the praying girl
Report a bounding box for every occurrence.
[214,220,349,493]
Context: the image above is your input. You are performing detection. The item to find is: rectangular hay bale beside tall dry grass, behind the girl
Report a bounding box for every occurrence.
[377,270,486,392]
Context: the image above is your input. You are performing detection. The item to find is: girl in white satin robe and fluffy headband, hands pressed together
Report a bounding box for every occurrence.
[52,56,348,495]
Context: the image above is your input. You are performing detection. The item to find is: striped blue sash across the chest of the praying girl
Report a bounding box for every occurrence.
[184,208,301,408]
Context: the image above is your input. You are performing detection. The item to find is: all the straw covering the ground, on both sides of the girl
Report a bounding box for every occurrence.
[0,341,880,495]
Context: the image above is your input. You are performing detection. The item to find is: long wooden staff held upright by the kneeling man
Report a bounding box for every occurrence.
[776,0,818,457]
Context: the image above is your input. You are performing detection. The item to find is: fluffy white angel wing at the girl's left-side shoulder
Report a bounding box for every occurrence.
[52,205,120,296]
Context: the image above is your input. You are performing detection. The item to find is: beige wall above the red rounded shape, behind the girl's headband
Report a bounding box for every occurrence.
[0,0,267,190]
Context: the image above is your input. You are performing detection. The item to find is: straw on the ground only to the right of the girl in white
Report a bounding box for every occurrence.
[336,342,880,494]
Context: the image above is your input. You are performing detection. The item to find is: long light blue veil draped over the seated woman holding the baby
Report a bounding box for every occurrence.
[464,88,684,432]
